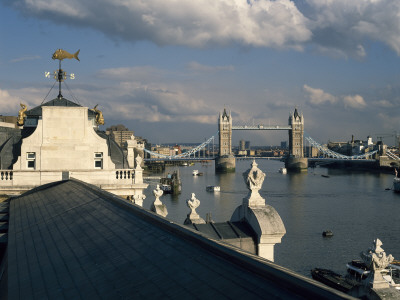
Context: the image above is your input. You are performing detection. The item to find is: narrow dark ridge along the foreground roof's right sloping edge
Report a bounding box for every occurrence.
[57,178,352,299]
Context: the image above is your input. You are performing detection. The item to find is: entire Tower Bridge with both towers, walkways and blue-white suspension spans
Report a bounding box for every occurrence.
[144,108,384,172]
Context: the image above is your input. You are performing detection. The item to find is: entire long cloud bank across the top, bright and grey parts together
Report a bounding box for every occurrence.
[6,0,400,58]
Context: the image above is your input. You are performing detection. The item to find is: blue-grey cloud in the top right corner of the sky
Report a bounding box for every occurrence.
[306,0,400,57]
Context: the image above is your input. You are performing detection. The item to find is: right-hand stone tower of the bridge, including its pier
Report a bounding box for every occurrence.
[286,108,308,171]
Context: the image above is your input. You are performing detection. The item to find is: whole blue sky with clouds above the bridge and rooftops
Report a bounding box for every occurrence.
[0,0,400,145]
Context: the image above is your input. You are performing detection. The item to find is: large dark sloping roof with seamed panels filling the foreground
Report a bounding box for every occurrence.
[4,180,352,300]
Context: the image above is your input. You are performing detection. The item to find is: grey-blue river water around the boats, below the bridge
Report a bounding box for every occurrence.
[143,160,400,277]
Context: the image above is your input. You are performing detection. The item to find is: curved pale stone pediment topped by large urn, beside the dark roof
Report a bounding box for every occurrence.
[231,161,286,261]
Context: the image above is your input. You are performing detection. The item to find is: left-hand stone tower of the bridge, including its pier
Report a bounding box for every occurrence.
[215,108,236,173]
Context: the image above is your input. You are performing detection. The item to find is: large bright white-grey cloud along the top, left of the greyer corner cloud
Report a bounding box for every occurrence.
[10,0,311,49]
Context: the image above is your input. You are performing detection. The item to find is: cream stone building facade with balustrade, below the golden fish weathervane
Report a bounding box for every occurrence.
[0,97,147,205]
